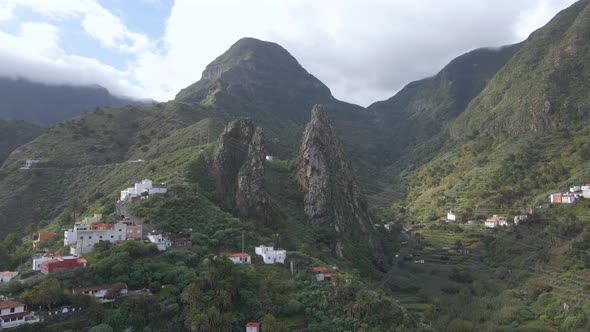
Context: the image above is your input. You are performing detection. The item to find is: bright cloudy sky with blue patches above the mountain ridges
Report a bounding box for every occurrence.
[0,0,575,106]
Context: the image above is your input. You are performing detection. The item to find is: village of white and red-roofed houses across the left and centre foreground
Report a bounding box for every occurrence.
[0,179,339,332]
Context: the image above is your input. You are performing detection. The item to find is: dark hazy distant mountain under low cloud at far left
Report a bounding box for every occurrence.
[0,77,146,125]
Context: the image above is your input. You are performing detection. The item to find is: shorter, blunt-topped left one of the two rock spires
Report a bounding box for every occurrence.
[210,119,271,225]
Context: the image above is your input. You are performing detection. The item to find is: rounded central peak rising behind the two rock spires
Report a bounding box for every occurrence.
[175,38,367,156]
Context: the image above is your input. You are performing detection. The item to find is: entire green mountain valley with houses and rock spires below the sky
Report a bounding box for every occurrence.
[0,0,590,332]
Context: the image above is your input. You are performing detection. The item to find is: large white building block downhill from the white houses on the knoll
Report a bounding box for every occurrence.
[64,219,127,255]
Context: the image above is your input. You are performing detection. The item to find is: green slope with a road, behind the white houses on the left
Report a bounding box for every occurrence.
[0,103,225,234]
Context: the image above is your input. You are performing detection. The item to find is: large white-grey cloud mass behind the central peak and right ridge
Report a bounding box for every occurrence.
[133,0,573,105]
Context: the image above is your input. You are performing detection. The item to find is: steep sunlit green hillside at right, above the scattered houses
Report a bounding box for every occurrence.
[406,1,590,219]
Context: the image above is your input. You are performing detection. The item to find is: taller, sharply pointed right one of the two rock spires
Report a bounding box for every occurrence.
[297,105,373,257]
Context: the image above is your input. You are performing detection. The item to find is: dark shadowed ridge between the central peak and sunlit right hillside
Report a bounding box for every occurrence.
[367,44,522,163]
